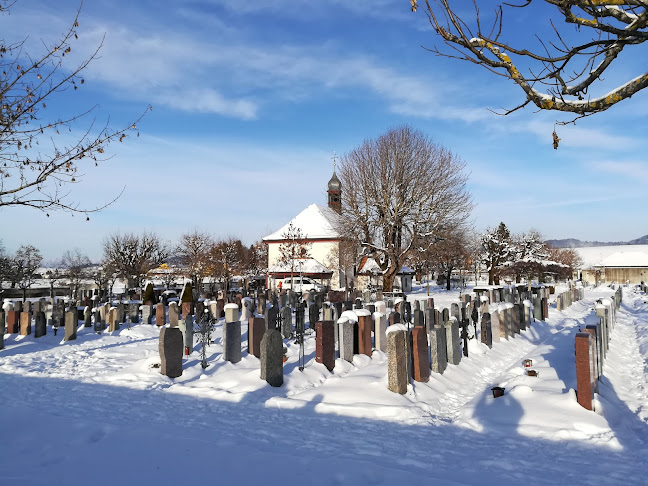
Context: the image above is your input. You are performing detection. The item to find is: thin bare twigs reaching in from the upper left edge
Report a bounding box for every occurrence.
[0,2,148,216]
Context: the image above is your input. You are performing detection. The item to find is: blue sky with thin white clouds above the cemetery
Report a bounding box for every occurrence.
[0,0,648,260]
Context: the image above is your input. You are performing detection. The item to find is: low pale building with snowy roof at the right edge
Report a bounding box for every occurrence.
[574,245,648,285]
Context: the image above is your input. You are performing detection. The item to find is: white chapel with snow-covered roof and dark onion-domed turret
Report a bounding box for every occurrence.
[262,171,348,289]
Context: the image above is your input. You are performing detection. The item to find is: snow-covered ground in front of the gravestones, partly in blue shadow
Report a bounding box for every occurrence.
[0,287,648,486]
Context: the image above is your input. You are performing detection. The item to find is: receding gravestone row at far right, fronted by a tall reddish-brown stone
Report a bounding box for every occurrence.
[574,286,623,410]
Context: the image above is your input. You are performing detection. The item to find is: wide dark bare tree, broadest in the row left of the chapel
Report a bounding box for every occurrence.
[103,232,169,288]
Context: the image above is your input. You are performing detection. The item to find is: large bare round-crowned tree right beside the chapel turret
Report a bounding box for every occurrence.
[340,126,472,291]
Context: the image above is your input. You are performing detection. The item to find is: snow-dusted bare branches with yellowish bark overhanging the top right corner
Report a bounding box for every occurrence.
[410,0,648,122]
